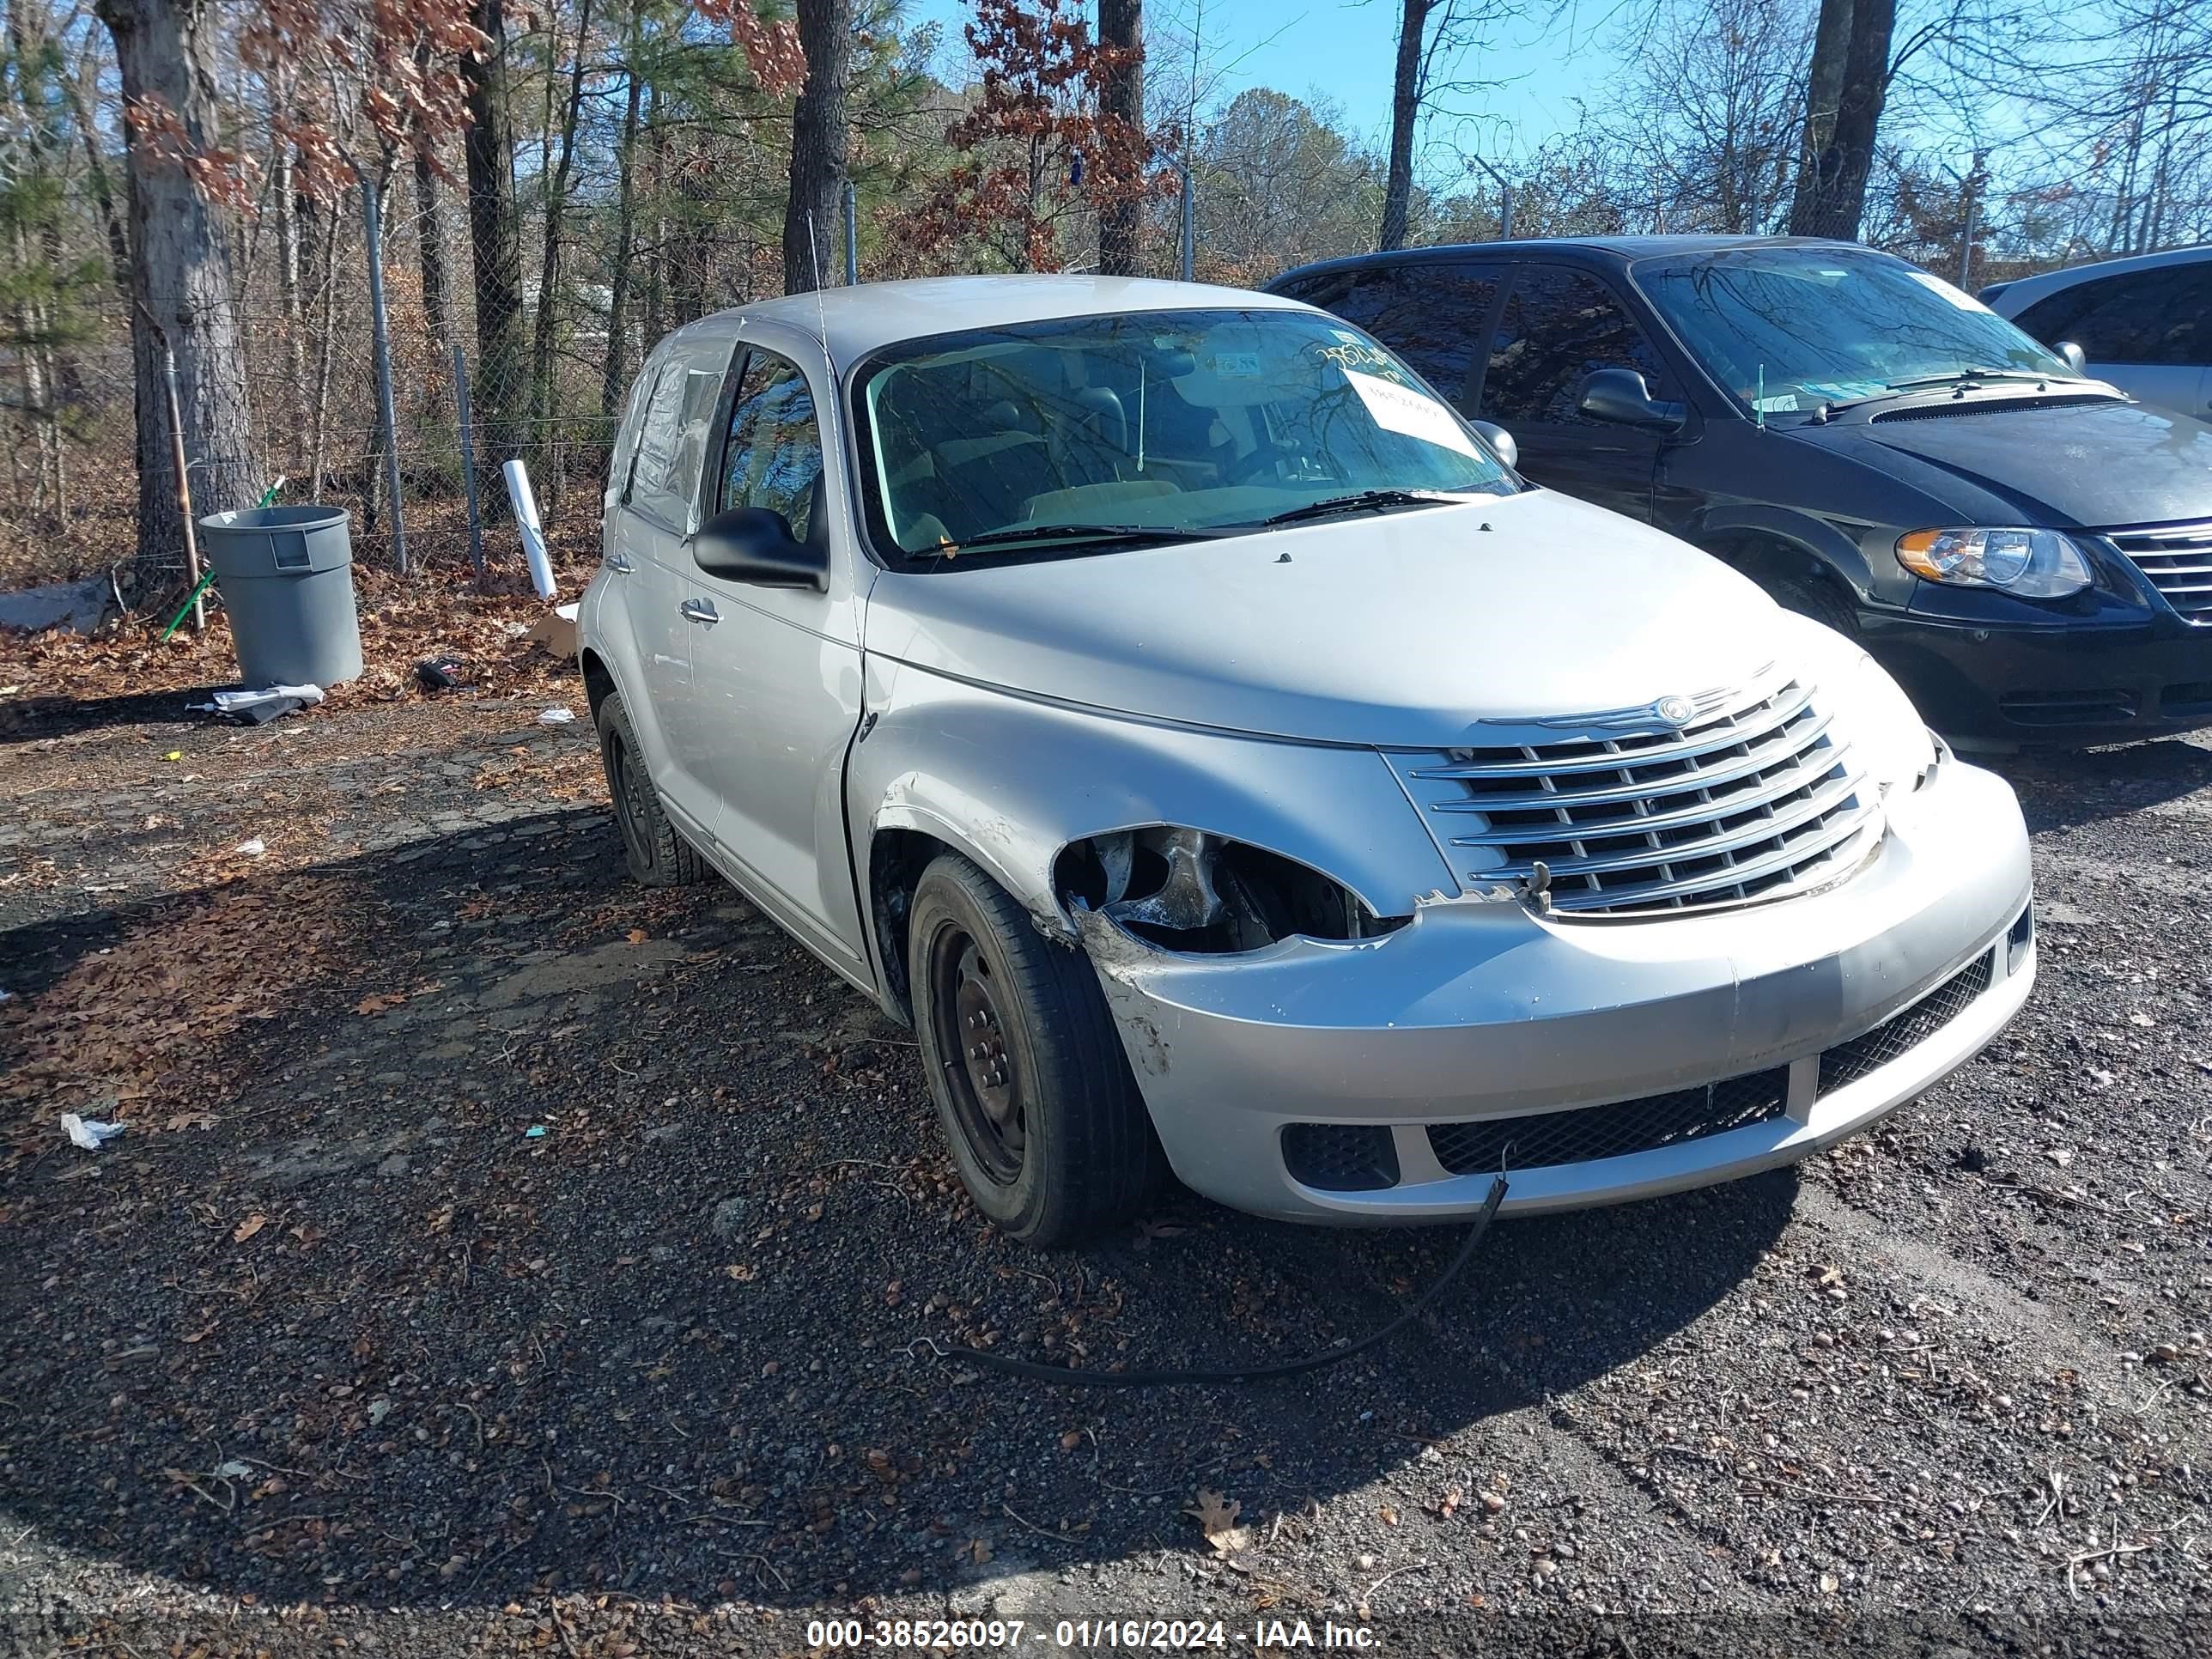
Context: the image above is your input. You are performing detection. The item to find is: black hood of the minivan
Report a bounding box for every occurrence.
[1790,398,2212,529]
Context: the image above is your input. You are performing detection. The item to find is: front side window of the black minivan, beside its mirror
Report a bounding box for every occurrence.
[1482,265,1668,427]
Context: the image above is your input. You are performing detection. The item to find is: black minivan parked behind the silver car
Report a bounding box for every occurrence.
[1272,237,2212,748]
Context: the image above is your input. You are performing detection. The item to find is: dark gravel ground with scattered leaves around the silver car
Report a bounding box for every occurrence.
[0,685,2212,1655]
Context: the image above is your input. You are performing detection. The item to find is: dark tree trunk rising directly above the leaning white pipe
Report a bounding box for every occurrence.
[460,0,529,471]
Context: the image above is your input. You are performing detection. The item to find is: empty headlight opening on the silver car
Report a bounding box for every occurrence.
[1053,825,1411,953]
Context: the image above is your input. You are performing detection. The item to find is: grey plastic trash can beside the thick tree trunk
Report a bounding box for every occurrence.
[199,507,361,688]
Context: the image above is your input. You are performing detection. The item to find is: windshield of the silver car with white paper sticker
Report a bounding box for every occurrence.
[856,310,1517,562]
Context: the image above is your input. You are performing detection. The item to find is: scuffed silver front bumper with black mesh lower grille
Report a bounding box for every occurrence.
[1082,763,2035,1224]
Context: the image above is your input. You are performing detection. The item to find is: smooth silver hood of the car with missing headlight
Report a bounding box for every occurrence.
[867,491,1783,748]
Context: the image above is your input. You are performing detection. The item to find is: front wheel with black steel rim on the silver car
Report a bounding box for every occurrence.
[907,854,1157,1248]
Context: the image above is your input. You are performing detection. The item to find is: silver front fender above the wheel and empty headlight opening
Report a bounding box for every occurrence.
[845,657,1458,945]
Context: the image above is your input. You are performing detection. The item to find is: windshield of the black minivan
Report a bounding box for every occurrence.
[1628,248,2073,424]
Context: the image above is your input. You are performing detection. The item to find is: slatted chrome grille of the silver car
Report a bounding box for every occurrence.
[1394,679,1878,914]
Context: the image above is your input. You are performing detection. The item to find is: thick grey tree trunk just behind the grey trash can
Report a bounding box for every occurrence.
[100,0,261,592]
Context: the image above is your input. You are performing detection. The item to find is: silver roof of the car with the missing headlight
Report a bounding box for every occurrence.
[654,272,1305,368]
